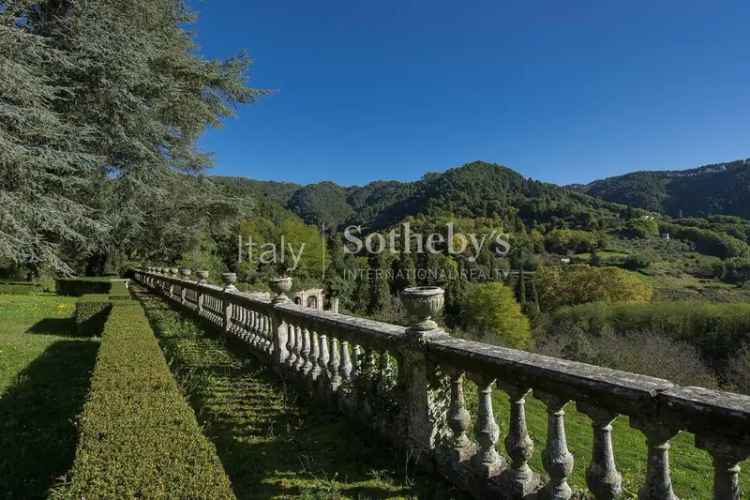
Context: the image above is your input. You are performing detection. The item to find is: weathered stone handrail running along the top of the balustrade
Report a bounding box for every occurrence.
[137,272,750,441]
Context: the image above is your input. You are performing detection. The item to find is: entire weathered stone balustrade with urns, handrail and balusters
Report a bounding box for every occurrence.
[135,268,750,500]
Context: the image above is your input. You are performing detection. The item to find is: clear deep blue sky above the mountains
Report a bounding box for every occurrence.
[190,0,750,185]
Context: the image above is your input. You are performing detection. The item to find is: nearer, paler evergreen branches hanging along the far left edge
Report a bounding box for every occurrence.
[0,2,104,272]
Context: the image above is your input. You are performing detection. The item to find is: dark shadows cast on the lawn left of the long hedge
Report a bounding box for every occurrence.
[0,338,98,500]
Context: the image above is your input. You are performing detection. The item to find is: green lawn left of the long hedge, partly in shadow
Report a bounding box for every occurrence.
[0,294,98,499]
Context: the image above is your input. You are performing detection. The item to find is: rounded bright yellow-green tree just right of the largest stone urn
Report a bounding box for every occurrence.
[462,283,531,347]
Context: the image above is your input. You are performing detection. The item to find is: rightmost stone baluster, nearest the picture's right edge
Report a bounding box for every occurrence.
[695,435,750,500]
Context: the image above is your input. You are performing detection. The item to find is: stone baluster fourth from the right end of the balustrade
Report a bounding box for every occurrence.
[535,392,574,500]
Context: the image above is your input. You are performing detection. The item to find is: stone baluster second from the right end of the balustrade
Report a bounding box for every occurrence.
[630,416,678,500]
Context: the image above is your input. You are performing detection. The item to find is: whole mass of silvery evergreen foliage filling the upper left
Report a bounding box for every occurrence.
[0,0,262,274]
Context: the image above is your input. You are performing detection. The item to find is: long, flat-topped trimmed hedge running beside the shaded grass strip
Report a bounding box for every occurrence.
[53,302,235,499]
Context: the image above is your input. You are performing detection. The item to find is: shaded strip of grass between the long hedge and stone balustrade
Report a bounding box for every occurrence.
[135,288,462,499]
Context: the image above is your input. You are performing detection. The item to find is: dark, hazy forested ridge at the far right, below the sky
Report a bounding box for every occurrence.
[577,159,750,218]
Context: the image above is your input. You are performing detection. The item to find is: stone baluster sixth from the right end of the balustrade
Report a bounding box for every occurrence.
[471,374,505,479]
